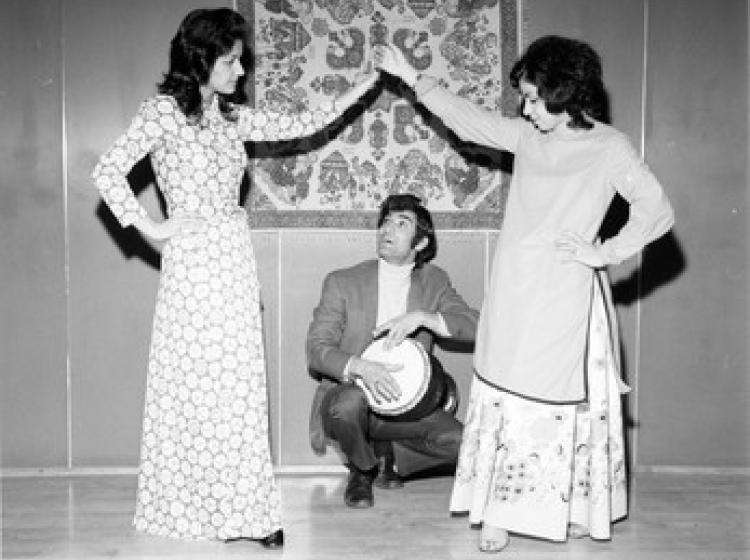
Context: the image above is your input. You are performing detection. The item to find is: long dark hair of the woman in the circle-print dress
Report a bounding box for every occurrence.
[158,8,248,120]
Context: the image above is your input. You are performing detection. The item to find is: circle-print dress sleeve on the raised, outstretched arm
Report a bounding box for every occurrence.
[236,101,346,142]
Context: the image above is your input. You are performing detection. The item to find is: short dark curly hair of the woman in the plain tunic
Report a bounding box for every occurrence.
[510,35,606,129]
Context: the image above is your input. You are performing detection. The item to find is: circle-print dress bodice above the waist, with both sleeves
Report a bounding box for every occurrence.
[93,95,338,226]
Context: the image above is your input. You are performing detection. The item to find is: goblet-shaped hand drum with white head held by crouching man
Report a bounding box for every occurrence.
[356,338,446,421]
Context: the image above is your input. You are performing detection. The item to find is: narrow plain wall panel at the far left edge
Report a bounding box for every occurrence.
[0,0,67,468]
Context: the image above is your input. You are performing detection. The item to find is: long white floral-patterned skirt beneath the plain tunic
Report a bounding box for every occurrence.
[450,283,627,541]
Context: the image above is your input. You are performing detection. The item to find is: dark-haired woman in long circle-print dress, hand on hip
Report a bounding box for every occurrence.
[93,8,377,547]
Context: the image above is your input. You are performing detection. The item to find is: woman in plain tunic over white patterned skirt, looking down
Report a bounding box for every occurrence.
[375,36,674,552]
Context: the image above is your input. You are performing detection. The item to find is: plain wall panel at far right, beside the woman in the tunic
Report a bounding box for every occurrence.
[639,0,750,467]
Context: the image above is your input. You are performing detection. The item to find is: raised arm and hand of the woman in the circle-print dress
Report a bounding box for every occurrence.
[238,69,379,142]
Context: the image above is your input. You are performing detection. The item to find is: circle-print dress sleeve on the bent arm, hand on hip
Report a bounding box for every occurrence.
[92,98,163,227]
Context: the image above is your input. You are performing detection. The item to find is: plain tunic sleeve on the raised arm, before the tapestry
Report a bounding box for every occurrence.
[414,76,528,153]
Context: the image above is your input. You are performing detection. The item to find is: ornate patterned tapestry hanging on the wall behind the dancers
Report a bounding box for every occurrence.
[237,0,518,229]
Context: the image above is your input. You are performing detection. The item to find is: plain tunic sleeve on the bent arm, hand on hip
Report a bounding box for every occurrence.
[602,138,674,264]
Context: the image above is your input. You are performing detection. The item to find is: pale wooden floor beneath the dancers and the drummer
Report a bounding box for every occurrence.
[0,474,750,560]
